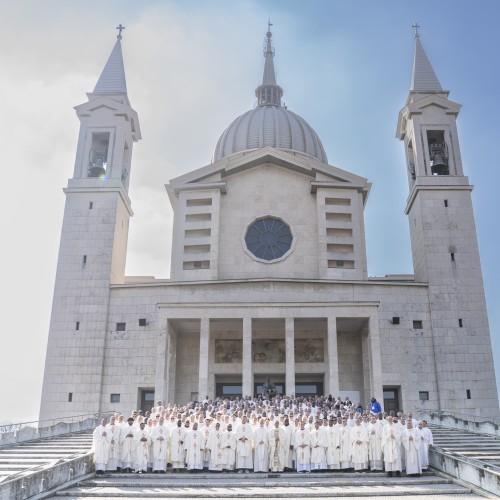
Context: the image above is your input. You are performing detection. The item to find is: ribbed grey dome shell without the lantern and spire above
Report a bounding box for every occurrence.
[214,105,328,163]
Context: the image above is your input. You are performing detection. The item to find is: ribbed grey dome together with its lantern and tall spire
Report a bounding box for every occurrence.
[213,24,328,163]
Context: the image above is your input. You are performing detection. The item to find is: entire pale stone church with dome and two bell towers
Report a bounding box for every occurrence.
[40,26,498,419]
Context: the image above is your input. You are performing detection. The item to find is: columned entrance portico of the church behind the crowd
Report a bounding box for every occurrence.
[155,303,382,401]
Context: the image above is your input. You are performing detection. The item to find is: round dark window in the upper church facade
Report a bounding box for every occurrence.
[245,217,293,261]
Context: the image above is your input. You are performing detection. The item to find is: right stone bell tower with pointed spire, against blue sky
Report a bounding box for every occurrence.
[397,24,499,416]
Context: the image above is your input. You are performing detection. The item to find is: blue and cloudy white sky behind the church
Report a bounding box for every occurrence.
[0,0,500,423]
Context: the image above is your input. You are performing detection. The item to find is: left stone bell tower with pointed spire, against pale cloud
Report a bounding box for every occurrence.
[40,25,141,420]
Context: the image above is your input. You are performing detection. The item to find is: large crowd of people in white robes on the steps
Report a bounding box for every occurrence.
[93,395,432,476]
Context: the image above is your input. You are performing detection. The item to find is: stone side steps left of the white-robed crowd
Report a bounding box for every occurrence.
[0,431,92,484]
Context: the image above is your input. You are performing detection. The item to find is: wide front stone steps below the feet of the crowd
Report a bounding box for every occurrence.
[49,472,480,500]
